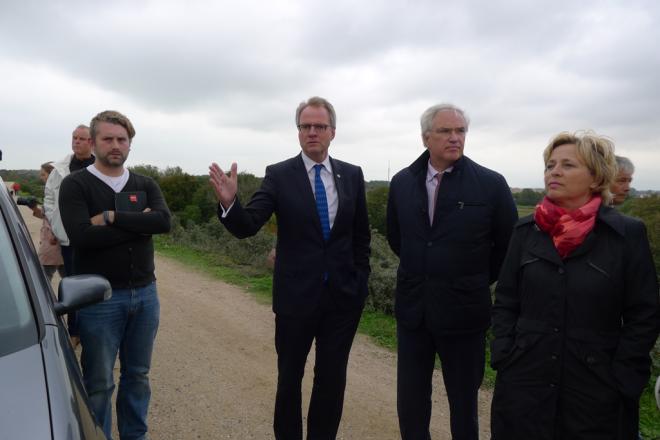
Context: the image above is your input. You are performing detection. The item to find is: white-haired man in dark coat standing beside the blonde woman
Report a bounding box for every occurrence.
[387,104,518,440]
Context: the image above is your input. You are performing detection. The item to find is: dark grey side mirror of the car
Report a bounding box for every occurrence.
[54,275,112,316]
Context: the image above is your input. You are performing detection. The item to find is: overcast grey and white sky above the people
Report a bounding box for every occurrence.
[0,0,660,190]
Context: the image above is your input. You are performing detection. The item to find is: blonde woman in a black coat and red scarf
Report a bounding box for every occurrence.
[491,133,660,440]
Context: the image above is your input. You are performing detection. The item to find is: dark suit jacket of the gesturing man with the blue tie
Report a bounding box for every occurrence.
[218,154,371,316]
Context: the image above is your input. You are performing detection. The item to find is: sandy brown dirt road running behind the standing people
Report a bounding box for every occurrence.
[21,207,491,440]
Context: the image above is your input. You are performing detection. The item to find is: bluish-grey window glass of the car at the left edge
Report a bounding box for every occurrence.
[0,208,37,356]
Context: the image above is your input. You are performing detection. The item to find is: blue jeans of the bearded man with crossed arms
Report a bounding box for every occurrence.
[78,282,160,440]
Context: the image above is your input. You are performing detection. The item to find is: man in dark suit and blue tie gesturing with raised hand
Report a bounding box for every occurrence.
[209,97,371,440]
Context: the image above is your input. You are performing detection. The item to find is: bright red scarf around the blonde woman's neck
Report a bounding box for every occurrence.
[534,196,602,259]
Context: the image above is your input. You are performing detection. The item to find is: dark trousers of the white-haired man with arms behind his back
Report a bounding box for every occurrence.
[397,324,485,440]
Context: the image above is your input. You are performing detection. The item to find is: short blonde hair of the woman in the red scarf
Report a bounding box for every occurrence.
[543,131,617,205]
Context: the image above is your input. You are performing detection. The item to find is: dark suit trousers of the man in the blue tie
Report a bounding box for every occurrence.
[273,296,362,440]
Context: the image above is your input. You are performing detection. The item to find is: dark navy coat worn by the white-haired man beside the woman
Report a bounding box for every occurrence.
[387,151,518,332]
